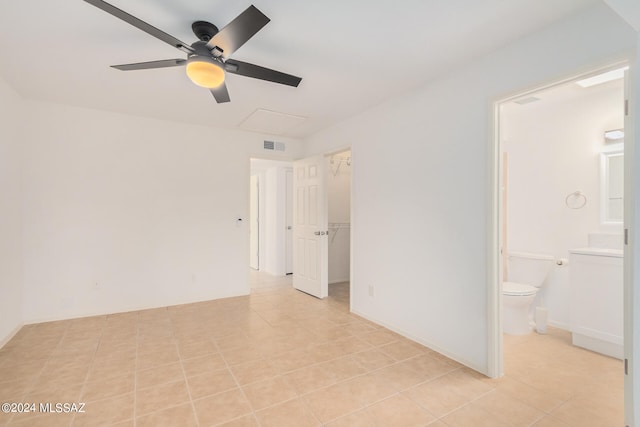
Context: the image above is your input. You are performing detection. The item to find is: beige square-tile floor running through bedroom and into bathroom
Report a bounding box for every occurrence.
[0,273,623,427]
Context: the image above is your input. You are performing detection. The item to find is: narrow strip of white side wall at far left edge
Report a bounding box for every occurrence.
[0,78,24,347]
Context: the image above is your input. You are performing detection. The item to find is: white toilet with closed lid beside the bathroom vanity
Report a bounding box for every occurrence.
[502,252,554,335]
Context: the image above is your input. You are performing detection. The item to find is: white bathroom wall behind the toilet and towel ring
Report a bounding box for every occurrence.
[501,80,624,329]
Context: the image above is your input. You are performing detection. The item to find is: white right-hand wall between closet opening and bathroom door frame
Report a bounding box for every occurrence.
[306,4,636,372]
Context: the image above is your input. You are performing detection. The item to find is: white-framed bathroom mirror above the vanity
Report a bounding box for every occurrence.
[600,148,624,224]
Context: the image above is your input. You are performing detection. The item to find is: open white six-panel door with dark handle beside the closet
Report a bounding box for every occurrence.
[293,155,329,298]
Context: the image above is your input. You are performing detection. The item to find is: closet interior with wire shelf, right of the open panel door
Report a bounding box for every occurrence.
[327,151,351,283]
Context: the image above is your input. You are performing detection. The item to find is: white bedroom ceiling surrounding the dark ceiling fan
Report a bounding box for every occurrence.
[0,0,599,137]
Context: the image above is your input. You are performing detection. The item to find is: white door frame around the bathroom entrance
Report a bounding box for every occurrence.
[486,58,640,425]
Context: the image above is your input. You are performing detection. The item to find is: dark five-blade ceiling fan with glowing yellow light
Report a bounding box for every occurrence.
[84,0,302,103]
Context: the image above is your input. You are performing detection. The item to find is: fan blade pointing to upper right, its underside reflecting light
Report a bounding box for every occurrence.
[207,5,270,59]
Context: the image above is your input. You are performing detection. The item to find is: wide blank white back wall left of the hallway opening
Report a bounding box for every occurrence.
[23,102,297,322]
